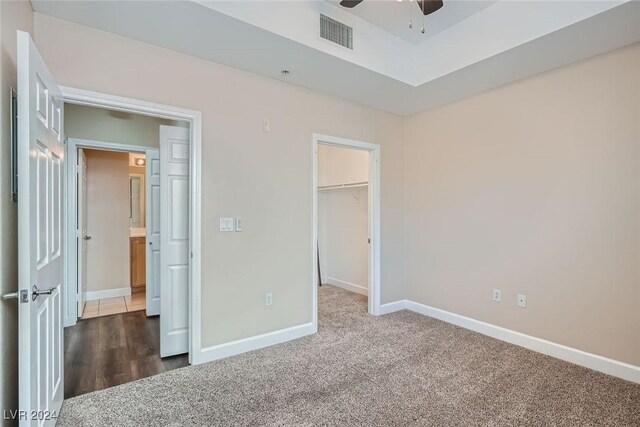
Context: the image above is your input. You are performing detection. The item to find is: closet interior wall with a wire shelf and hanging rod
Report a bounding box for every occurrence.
[318,145,369,295]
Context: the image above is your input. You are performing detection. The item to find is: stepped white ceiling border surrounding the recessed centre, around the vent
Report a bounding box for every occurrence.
[32,0,640,115]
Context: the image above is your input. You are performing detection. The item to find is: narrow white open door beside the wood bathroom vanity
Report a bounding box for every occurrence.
[145,149,160,316]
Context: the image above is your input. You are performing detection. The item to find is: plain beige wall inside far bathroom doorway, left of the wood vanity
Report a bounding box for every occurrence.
[85,150,131,292]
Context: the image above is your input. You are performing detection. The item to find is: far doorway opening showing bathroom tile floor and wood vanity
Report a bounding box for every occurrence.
[76,148,147,319]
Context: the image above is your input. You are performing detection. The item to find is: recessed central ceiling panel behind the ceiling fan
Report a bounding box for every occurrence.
[326,0,496,44]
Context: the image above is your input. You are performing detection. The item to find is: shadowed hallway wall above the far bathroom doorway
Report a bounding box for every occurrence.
[64,104,187,147]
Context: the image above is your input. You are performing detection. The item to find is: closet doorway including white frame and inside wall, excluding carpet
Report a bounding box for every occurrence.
[312,134,380,326]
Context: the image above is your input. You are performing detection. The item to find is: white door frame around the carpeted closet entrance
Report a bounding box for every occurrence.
[311,133,380,328]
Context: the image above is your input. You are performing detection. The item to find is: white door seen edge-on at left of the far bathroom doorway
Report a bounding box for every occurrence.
[76,149,91,318]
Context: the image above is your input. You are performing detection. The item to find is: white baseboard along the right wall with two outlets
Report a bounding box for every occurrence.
[404,301,640,383]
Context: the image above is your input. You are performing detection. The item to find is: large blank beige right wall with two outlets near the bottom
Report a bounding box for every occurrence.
[405,44,640,365]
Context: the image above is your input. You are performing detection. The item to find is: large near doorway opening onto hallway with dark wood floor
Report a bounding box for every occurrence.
[64,105,192,398]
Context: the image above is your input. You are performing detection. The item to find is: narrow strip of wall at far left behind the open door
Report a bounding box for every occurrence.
[0,0,33,425]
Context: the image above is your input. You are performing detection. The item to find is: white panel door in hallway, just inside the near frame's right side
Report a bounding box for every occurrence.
[160,126,189,357]
